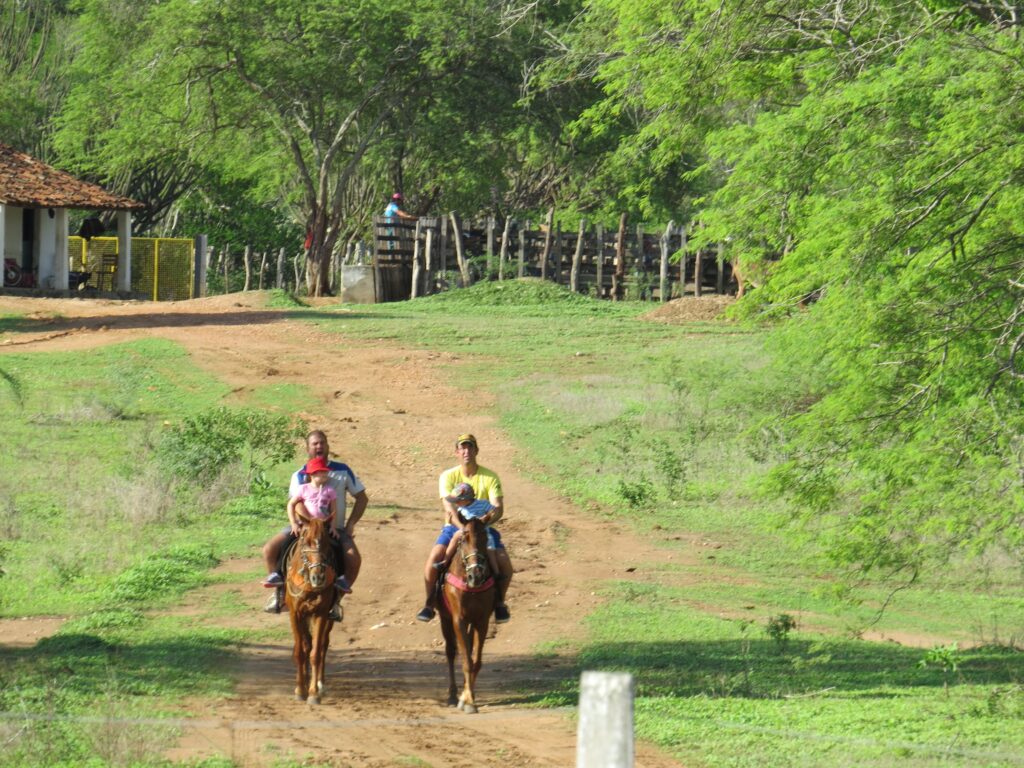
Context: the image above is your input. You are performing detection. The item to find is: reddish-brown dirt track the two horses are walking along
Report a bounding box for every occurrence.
[0,294,678,768]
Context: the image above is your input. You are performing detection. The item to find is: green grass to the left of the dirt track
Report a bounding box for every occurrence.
[0,341,296,767]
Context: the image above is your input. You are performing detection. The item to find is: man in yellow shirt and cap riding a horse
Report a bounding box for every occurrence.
[416,434,513,624]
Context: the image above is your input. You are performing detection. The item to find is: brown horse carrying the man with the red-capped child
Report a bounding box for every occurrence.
[285,520,336,705]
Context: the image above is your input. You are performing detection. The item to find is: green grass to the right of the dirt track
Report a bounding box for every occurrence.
[284,281,1024,766]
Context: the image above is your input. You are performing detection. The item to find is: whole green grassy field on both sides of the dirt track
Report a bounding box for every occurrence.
[0,282,1024,766]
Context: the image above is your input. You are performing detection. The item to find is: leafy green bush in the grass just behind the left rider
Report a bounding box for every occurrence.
[157,407,306,487]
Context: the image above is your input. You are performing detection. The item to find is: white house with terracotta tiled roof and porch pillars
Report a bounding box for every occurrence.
[0,143,145,292]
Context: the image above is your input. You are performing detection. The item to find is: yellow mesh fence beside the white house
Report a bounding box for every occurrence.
[68,237,195,301]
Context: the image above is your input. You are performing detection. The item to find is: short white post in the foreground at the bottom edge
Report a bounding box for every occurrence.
[577,672,634,768]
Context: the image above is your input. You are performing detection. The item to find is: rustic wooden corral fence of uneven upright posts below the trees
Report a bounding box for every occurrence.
[374,214,732,301]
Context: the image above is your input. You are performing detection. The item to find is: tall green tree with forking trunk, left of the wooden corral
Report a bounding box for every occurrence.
[66,0,544,294]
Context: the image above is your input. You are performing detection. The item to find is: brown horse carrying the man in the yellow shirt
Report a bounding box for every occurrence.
[438,519,495,714]
